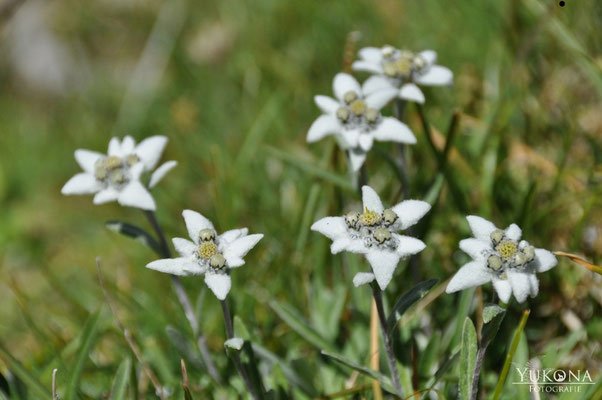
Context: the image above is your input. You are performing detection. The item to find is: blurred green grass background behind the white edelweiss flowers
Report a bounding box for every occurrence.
[0,0,602,398]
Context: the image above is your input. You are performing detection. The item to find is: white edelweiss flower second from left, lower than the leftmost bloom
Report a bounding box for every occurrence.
[146,210,263,300]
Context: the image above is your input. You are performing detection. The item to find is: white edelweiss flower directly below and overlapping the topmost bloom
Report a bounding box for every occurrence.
[307,73,416,171]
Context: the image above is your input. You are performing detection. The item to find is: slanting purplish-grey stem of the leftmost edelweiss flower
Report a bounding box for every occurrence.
[144,210,221,382]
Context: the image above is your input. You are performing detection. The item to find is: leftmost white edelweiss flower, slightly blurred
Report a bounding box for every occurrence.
[61,136,176,210]
